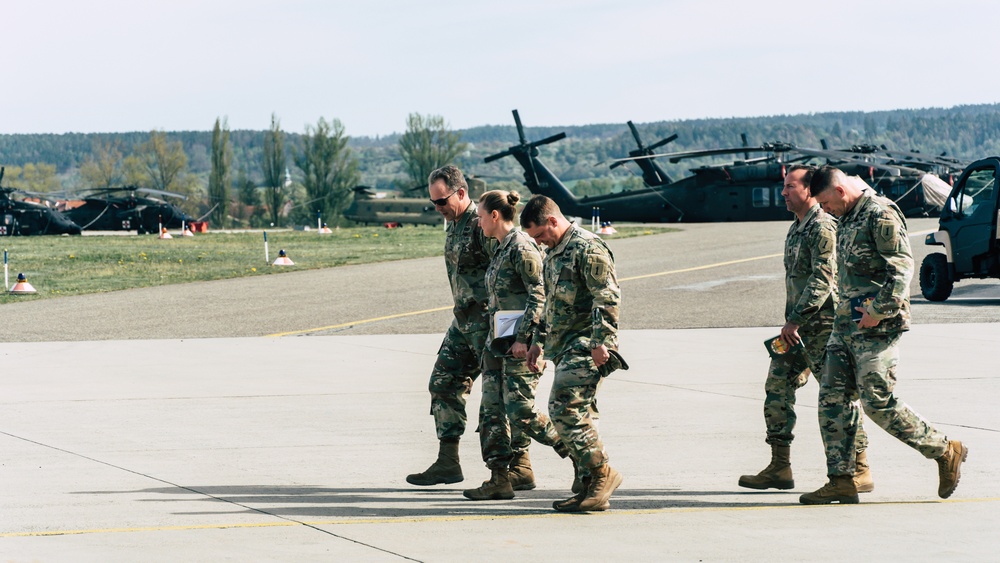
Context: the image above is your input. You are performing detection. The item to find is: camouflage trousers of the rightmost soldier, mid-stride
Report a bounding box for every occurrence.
[819,332,948,475]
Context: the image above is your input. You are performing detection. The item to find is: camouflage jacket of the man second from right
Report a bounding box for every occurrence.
[785,204,837,333]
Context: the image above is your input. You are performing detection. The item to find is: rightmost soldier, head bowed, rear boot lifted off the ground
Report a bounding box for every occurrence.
[799,166,969,504]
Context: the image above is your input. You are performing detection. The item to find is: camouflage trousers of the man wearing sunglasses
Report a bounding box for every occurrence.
[427,321,489,440]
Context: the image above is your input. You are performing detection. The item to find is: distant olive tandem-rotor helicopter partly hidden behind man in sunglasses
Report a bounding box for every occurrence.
[344,176,486,226]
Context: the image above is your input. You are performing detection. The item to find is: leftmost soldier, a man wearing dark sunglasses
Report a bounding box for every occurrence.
[406,165,526,485]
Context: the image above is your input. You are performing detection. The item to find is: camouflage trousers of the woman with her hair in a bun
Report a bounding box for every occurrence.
[479,348,559,469]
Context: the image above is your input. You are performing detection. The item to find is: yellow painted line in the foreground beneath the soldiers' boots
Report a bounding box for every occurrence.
[0,497,1000,538]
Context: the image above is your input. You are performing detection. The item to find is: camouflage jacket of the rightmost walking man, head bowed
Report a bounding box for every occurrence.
[834,190,913,334]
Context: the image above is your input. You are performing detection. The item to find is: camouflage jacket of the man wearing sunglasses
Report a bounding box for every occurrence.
[444,203,496,330]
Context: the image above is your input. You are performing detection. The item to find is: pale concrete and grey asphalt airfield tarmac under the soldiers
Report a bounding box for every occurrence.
[0,220,1000,561]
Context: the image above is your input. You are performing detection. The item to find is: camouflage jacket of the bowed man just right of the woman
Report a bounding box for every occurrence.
[535,225,621,361]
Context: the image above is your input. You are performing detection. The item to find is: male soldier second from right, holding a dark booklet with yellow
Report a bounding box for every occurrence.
[739,166,875,492]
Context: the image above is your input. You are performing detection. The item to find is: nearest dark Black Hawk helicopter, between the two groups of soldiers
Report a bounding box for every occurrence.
[485,110,789,222]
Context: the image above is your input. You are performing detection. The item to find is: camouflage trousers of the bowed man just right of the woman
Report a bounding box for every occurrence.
[549,350,608,472]
